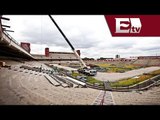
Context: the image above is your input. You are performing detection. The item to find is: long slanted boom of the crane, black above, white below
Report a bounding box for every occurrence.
[49,15,86,67]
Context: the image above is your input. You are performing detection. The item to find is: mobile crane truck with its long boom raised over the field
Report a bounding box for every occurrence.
[49,15,97,75]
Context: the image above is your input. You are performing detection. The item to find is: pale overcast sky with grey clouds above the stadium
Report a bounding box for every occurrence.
[2,15,160,58]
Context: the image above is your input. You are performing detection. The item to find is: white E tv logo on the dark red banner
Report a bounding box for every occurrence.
[115,18,142,33]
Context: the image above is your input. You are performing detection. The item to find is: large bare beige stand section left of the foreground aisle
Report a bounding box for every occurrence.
[0,62,99,105]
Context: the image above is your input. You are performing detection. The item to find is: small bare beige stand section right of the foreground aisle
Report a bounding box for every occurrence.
[112,86,160,105]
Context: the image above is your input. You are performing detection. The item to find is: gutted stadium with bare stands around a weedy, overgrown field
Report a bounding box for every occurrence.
[0,16,160,105]
